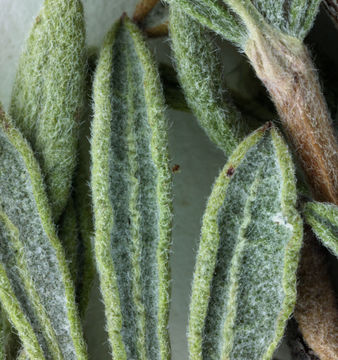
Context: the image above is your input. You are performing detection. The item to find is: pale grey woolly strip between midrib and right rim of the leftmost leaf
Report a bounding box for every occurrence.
[0,133,76,360]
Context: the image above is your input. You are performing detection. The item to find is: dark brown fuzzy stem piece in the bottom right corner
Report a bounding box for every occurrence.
[294,228,338,360]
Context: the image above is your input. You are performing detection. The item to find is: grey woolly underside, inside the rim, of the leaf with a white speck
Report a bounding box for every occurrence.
[203,138,292,360]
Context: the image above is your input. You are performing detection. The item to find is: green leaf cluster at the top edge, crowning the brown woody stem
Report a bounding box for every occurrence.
[166,0,321,48]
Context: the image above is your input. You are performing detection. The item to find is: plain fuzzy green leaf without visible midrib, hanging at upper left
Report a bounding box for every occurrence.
[10,0,86,219]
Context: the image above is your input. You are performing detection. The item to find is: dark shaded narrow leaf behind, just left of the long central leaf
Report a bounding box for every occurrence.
[59,49,97,318]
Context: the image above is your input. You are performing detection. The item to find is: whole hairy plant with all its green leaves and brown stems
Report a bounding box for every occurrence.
[0,0,338,360]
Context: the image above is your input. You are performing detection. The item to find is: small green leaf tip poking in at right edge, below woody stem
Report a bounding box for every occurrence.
[304,201,338,257]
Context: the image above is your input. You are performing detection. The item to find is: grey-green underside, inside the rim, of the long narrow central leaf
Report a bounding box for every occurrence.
[110,26,159,359]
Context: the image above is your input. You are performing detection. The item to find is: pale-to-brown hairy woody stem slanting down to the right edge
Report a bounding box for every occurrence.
[245,32,338,204]
